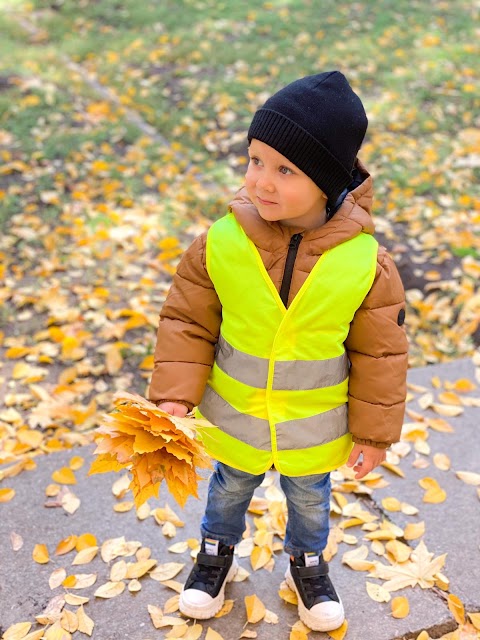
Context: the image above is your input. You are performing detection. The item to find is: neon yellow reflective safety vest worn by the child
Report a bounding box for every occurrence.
[197,213,378,476]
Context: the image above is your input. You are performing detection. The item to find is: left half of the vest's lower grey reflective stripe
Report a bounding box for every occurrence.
[198,384,272,451]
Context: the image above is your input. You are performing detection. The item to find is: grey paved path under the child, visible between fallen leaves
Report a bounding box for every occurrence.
[0,360,480,640]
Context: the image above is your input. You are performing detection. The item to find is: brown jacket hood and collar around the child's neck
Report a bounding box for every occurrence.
[229,160,375,255]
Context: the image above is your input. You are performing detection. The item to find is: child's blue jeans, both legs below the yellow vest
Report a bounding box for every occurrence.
[201,462,330,556]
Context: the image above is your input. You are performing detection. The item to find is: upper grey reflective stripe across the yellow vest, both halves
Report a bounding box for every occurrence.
[215,336,348,391]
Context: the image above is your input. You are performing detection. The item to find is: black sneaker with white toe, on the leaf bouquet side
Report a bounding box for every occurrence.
[179,538,238,620]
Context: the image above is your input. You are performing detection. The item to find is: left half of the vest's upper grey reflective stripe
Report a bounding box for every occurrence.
[215,335,268,389]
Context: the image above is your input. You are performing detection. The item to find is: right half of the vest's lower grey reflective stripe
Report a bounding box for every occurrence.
[276,404,348,450]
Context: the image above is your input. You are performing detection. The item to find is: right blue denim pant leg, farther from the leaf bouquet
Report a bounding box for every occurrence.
[280,473,330,556]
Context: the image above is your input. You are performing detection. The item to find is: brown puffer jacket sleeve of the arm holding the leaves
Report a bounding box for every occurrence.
[148,233,222,409]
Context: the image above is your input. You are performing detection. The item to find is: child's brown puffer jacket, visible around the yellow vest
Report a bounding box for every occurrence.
[149,163,408,448]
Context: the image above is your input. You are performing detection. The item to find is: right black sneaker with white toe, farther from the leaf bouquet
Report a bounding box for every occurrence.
[285,553,345,631]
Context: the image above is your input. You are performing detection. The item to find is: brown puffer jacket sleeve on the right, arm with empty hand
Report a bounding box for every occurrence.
[345,247,408,448]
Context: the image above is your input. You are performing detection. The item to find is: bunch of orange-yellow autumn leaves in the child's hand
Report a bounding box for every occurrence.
[89,392,211,509]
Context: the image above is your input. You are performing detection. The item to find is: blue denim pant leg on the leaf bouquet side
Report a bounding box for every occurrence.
[200,462,265,545]
